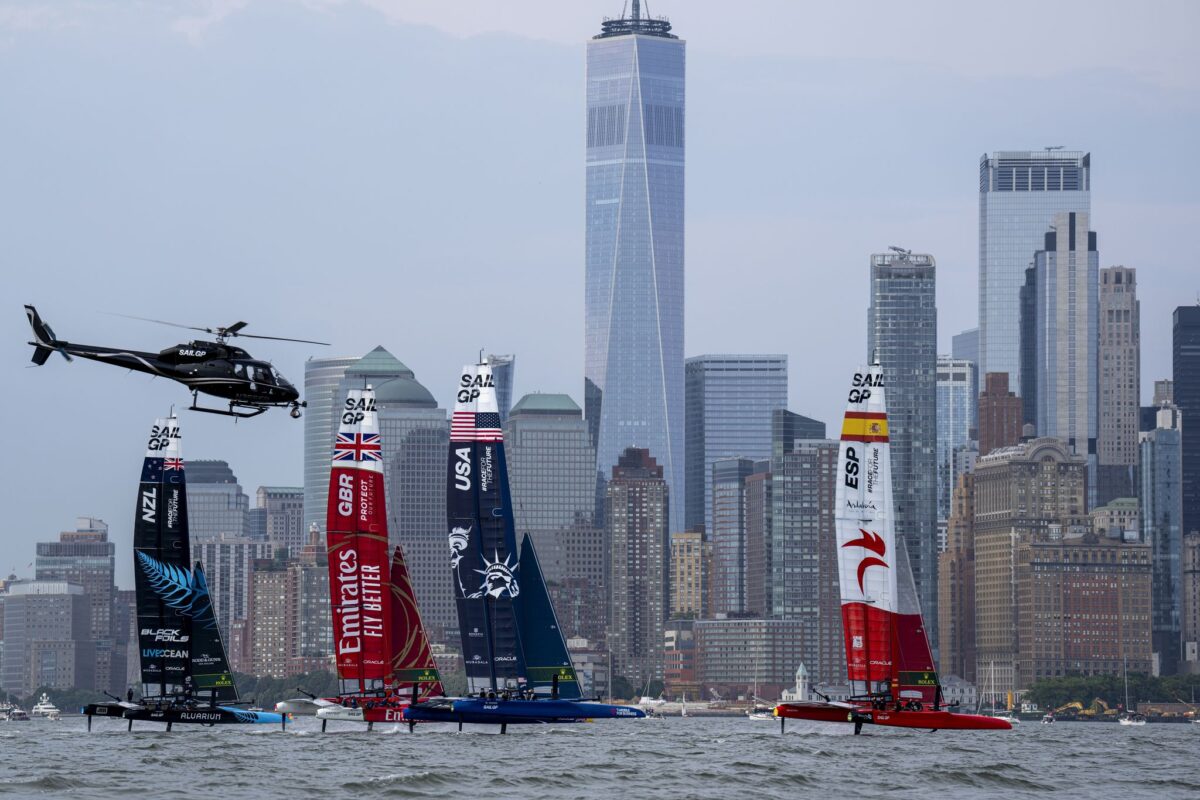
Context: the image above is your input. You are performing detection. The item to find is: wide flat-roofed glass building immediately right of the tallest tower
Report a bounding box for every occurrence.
[684,355,787,531]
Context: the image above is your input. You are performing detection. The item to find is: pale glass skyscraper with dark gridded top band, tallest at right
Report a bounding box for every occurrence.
[979,148,1092,393]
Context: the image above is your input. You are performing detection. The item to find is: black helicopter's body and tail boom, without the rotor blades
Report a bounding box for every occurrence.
[46,341,300,407]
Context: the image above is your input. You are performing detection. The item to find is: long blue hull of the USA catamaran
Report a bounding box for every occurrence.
[404,697,646,724]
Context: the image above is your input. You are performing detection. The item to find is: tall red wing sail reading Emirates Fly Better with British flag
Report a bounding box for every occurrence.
[325,389,391,693]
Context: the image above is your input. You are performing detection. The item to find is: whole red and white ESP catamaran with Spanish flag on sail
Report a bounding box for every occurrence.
[775,363,1012,734]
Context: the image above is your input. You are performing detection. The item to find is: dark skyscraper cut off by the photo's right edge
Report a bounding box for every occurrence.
[1171,305,1200,544]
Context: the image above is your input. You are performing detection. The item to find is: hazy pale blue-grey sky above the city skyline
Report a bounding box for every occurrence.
[0,0,1200,585]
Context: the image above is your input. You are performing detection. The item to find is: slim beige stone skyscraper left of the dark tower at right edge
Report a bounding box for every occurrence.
[1096,266,1141,505]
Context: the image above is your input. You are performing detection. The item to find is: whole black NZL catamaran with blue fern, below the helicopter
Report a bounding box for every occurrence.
[83,416,287,730]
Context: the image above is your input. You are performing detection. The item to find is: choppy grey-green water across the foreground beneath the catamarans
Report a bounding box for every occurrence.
[0,717,1200,800]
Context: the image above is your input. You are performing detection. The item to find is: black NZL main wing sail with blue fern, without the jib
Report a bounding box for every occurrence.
[133,417,192,697]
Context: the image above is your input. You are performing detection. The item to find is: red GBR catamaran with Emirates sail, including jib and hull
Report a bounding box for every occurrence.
[309,386,444,730]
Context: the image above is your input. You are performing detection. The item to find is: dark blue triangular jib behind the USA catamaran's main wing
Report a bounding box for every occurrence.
[516,534,582,700]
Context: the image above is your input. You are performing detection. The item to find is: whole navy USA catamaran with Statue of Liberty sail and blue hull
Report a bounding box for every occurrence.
[404,363,644,733]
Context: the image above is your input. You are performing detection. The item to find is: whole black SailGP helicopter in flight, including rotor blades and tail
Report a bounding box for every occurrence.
[25,306,328,419]
